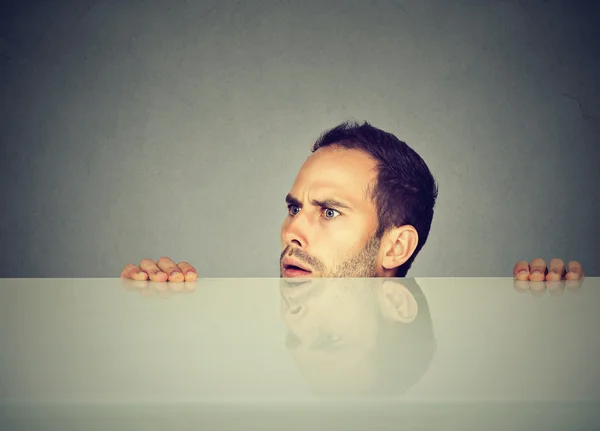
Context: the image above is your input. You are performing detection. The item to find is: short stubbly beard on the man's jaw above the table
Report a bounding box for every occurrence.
[279,235,381,278]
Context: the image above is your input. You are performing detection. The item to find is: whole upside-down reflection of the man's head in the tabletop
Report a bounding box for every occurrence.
[280,278,426,397]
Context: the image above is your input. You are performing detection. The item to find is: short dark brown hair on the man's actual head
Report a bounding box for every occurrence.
[311,121,438,277]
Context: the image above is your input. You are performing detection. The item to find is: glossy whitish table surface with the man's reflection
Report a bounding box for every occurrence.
[0,278,600,430]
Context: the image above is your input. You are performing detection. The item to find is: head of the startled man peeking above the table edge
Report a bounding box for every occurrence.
[280,123,437,278]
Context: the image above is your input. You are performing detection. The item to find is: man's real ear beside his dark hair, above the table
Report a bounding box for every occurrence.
[380,225,419,276]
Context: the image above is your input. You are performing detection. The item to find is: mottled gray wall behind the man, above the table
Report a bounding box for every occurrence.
[0,1,600,277]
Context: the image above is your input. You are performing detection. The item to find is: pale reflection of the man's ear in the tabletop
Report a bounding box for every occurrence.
[378,280,419,323]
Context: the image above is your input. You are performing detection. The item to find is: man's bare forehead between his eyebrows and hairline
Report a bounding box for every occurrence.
[294,146,377,196]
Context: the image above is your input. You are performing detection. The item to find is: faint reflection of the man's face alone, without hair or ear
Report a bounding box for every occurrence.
[282,280,378,392]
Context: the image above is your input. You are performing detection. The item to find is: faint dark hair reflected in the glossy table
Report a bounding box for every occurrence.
[369,278,436,396]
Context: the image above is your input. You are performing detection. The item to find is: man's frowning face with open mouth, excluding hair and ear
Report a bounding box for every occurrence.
[280,146,380,278]
